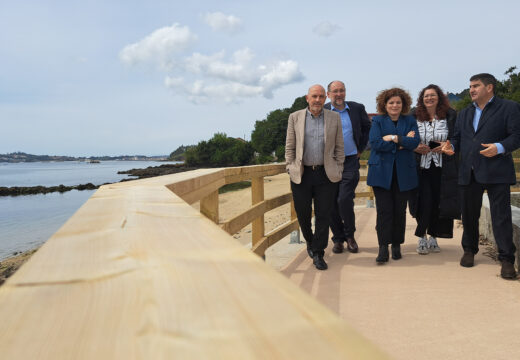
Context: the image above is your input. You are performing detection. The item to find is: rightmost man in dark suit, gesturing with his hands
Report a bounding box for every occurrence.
[443,74,520,279]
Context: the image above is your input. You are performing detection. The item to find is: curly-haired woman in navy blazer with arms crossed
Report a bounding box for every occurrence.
[367,88,420,264]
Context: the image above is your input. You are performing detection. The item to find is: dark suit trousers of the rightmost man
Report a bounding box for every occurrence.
[461,172,516,264]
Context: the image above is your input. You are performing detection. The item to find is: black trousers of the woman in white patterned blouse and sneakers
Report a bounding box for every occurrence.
[415,166,453,237]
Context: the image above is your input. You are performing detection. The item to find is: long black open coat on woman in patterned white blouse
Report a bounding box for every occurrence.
[408,109,461,221]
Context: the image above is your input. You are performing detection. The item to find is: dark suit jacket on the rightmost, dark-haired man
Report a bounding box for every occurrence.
[451,96,520,185]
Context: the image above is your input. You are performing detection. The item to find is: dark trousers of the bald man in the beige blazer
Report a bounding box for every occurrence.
[291,166,338,255]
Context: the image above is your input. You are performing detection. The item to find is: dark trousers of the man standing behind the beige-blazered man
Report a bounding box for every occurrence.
[330,155,359,243]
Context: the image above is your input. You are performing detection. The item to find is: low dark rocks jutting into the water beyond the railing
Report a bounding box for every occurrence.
[0,164,198,196]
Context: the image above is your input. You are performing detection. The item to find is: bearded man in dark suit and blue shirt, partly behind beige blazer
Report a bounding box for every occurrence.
[324,81,370,254]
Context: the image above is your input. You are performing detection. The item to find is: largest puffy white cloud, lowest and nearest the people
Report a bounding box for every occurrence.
[164,48,303,103]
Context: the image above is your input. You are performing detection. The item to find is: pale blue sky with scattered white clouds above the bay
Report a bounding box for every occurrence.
[0,0,520,156]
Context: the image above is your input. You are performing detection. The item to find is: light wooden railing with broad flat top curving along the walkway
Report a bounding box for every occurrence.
[0,165,385,360]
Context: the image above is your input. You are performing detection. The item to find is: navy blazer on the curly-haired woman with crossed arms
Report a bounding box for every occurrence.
[367,115,421,191]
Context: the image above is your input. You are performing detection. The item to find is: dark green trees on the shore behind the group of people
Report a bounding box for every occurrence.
[176,66,520,167]
